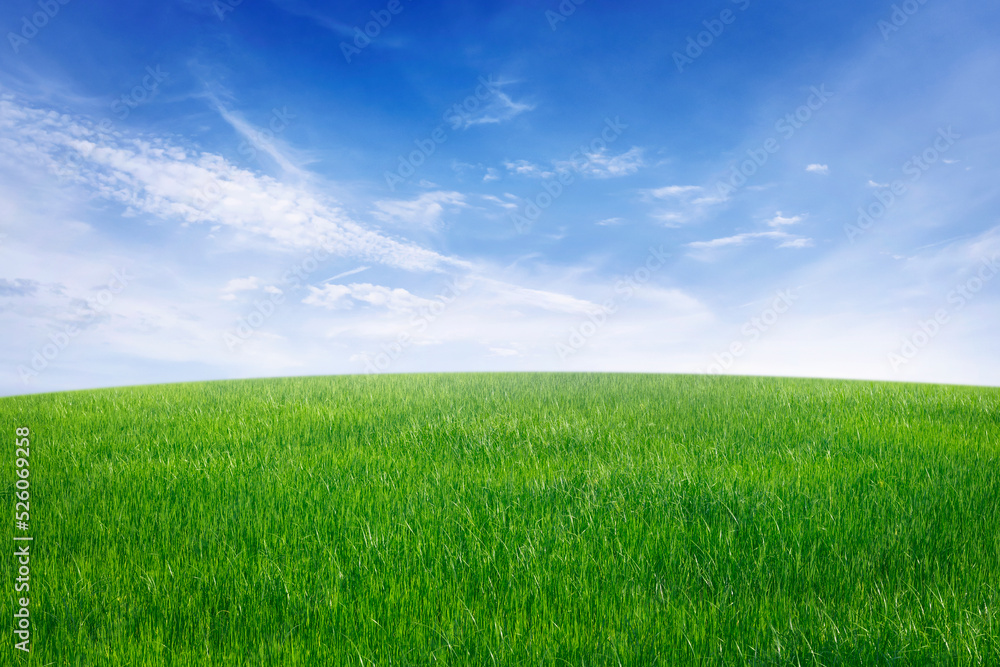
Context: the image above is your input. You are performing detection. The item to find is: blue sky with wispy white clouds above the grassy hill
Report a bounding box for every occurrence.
[0,0,1000,395]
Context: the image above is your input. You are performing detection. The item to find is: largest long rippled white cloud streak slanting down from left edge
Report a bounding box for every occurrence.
[0,98,460,271]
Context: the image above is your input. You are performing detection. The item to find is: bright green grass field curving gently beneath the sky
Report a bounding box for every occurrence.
[0,374,1000,666]
